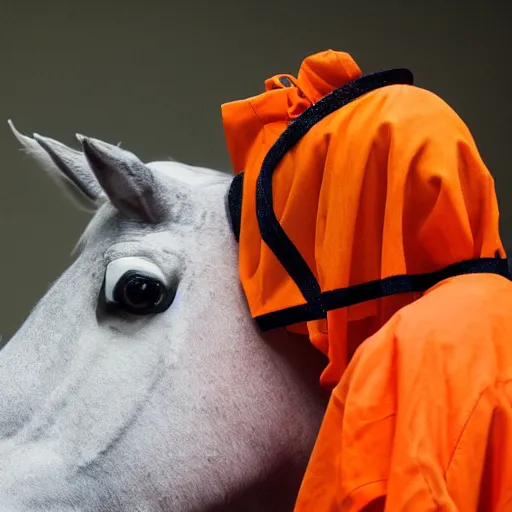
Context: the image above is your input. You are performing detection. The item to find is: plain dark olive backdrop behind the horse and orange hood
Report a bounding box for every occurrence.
[0,0,512,343]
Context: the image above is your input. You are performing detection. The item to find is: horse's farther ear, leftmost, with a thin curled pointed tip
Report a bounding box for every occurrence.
[8,120,106,211]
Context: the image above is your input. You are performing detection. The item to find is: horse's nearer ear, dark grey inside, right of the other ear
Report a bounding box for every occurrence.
[76,134,166,224]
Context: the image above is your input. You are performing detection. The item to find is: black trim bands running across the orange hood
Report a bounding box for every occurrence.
[228,69,509,331]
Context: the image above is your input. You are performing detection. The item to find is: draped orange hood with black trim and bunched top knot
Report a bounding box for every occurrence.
[222,51,508,376]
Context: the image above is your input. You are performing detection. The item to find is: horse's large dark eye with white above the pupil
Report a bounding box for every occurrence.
[104,258,176,315]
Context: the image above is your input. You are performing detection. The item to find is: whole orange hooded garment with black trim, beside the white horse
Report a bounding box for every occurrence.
[222,51,512,512]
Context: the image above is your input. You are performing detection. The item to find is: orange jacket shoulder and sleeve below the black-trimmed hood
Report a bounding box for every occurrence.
[295,276,512,512]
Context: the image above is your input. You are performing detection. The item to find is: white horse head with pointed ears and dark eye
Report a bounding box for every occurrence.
[0,125,325,512]
